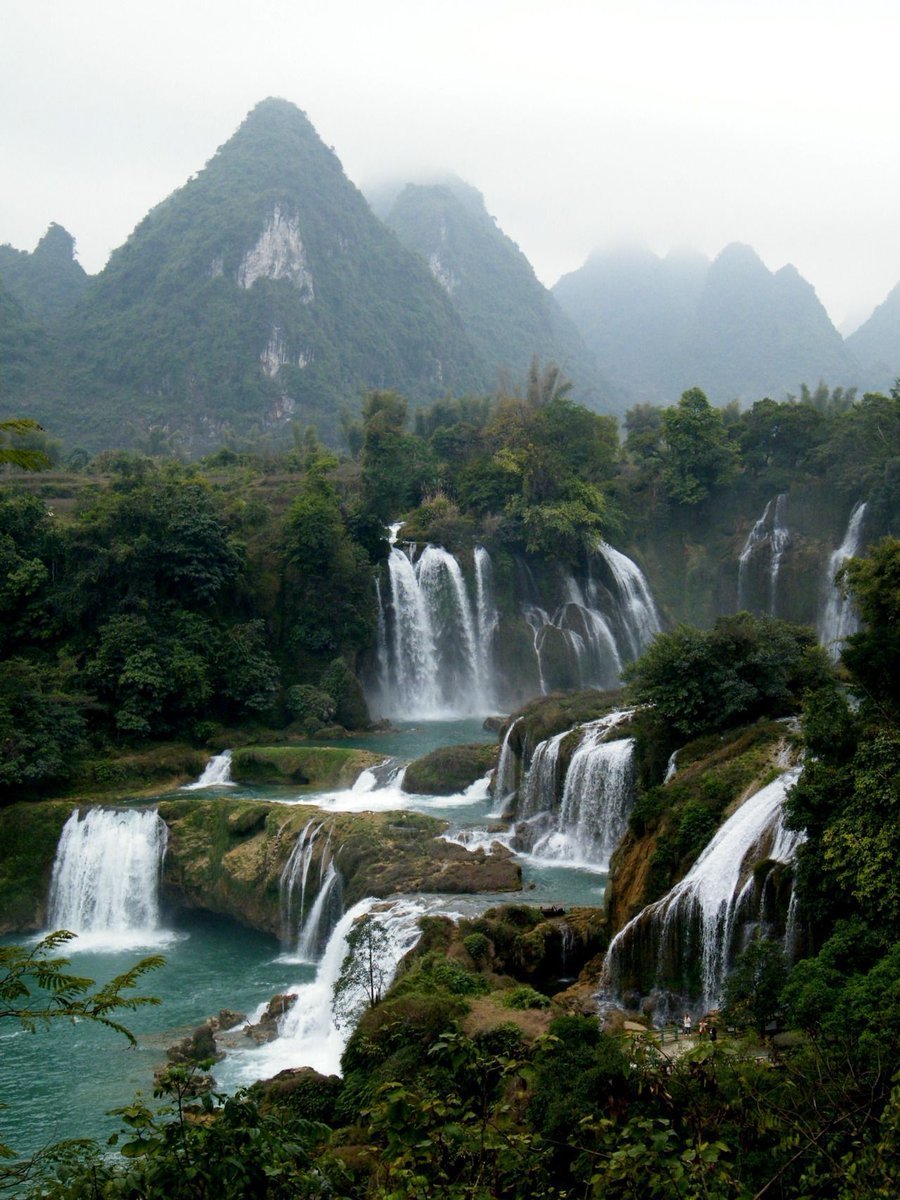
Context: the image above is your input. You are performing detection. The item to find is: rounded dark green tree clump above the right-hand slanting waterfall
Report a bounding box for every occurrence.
[625,613,828,737]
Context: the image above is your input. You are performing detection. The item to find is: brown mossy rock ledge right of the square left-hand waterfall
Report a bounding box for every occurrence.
[160,798,522,935]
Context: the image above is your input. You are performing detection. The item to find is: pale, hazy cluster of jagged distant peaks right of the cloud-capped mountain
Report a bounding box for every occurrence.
[553,242,863,404]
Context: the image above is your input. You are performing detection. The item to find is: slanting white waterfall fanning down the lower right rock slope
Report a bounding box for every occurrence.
[604,768,802,1010]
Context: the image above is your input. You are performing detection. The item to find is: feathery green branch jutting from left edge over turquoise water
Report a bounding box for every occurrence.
[0,929,164,1045]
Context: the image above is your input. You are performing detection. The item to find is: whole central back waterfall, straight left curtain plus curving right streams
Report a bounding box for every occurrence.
[372,526,660,719]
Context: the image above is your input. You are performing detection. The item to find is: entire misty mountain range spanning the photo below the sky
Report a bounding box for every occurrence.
[0,100,900,455]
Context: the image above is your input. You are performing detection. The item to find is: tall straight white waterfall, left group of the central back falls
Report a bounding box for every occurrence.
[377,537,497,719]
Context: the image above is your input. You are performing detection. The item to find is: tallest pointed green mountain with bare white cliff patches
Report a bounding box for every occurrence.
[22,100,488,452]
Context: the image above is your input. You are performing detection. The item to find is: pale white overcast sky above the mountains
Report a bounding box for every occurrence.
[0,0,900,325]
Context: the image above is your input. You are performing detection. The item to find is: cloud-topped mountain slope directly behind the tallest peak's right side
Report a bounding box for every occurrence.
[373,176,612,408]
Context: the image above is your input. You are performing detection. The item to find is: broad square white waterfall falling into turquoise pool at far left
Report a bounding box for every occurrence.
[48,809,169,949]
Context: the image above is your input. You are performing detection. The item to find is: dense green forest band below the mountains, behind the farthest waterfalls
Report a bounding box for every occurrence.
[0,376,900,794]
